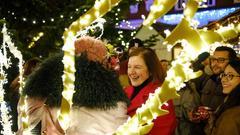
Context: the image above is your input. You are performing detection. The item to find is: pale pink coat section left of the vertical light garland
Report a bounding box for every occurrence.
[16,98,64,135]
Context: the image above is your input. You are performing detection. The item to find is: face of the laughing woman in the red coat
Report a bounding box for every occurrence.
[128,56,149,87]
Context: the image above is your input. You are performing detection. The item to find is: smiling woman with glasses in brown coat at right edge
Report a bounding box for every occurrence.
[206,59,240,135]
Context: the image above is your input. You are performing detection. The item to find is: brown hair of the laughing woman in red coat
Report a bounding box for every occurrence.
[129,47,165,83]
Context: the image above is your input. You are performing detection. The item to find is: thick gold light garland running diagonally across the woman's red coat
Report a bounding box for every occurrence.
[115,0,238,135]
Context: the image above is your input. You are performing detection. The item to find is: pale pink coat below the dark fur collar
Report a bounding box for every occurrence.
[17,98,128,135]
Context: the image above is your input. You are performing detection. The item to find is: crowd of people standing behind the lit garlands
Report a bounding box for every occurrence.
[2,36,240,135]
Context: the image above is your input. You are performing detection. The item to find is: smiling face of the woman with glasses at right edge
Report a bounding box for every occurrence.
[220,65,240,94]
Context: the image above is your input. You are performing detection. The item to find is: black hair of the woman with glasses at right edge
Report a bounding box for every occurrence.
[216,59,240,117]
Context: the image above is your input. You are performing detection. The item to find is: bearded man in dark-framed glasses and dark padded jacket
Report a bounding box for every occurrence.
[201,46,237,110]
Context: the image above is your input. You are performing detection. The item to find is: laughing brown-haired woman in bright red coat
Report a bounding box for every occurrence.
[125,47,176,135]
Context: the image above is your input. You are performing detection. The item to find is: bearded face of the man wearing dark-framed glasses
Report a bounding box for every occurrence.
[210,51,229,74]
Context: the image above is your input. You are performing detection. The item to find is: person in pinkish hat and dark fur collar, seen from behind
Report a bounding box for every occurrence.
[19,37,129,135]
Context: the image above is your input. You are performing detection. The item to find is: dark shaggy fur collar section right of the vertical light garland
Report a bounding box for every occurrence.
[73,52,130,109]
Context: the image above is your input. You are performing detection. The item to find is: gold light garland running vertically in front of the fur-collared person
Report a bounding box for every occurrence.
[58,0,121,130]
